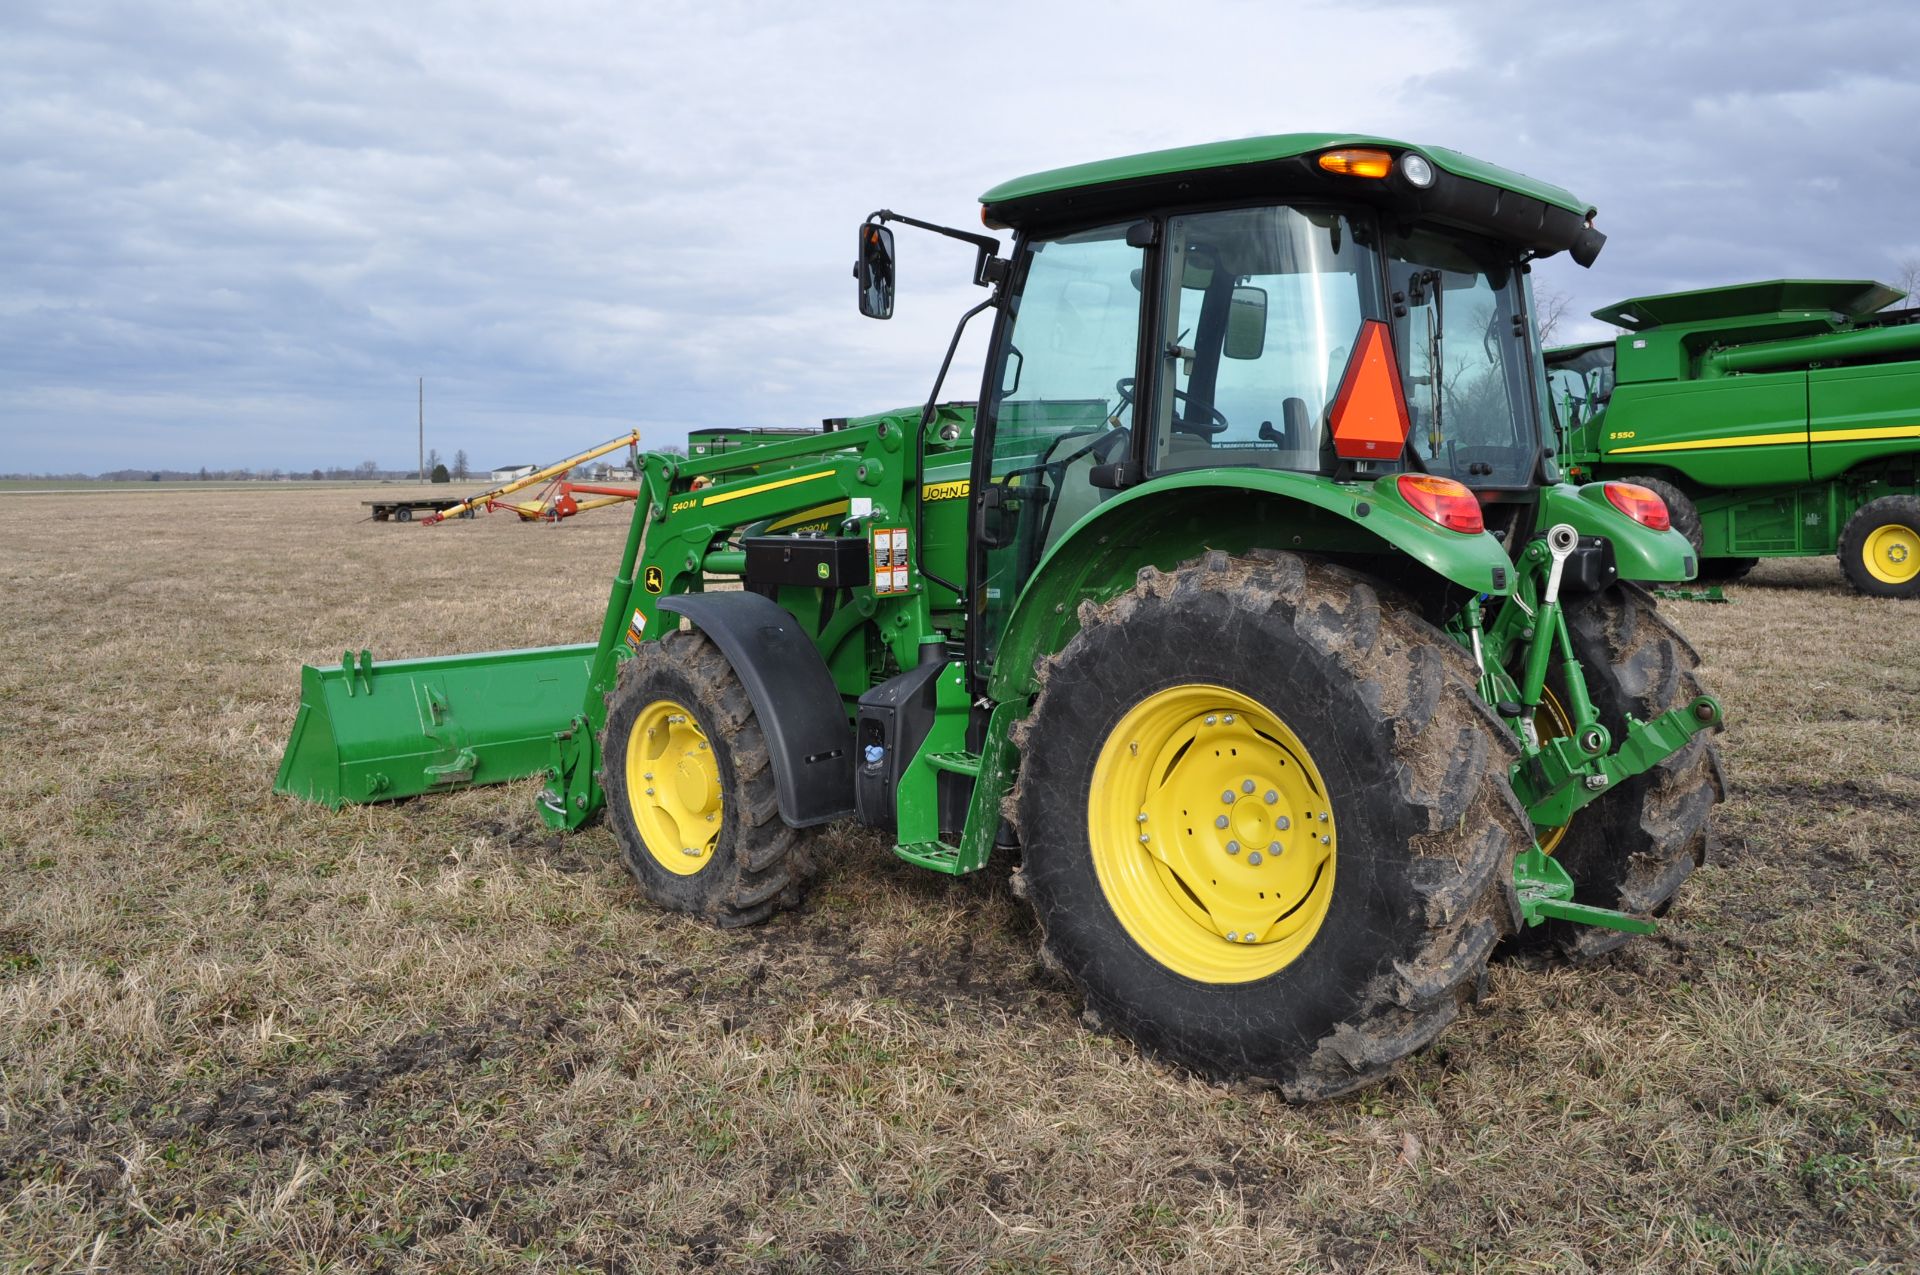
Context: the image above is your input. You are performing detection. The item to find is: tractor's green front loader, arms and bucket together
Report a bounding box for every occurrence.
[275,407,972,828]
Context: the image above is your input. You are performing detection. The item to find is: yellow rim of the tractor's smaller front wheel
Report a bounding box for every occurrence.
[626,699,724,876]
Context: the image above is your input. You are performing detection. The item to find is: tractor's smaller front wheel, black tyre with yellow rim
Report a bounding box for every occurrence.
[601,632,812,926]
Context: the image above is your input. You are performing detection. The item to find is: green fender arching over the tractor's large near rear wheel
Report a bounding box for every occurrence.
[989,469,1513,699]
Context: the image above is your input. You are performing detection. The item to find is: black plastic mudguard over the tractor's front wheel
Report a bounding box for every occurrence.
[660,591,854,828]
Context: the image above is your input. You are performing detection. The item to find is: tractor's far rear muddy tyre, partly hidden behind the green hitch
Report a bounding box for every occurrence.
[1523,584,1726,960]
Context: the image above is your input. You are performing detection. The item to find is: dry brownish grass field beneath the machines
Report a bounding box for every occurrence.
[0,488,1920,1275]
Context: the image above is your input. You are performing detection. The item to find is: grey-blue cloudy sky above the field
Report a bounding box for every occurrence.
[0,0,1920,472]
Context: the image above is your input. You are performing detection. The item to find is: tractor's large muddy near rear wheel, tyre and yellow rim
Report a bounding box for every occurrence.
[1008,551,1530,1100]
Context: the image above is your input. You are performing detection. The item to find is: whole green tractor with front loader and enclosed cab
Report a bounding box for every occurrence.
[276,134,1722,1100]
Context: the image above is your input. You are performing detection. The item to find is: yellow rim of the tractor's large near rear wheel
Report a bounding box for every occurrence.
[1087,684,1340,983]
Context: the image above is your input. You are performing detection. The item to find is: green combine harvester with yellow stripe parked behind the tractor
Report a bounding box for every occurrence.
[1548,278,1920,597]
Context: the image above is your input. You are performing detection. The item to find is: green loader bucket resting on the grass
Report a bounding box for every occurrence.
[273,643,595,808]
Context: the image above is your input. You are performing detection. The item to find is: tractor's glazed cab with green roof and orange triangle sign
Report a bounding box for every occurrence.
[925,134,1605,659]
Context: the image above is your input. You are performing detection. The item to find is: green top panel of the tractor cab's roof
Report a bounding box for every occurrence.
[979,132,1594,217]
